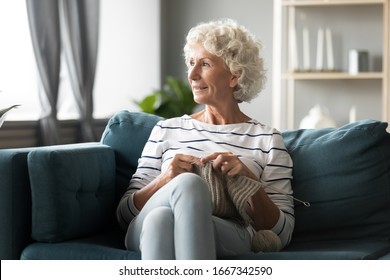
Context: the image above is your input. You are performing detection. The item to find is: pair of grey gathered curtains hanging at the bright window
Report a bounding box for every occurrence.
[26,0,100,145]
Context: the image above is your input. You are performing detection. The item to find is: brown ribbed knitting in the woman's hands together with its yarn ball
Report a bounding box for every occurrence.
[193,163,282,252]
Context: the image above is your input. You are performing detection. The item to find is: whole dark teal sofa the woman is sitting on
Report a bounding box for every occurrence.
[0,111,390,260]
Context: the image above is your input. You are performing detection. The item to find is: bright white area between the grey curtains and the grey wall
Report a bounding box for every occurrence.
[94,0,161,118]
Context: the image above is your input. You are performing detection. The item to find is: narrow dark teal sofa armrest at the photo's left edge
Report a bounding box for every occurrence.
[0,148,32,260]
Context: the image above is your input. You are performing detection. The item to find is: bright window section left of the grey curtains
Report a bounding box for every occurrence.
[0,1,40,120]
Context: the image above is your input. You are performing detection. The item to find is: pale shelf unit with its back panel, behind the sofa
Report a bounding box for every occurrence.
[272,0,390,132]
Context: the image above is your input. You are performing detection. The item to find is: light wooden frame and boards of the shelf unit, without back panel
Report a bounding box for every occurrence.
[273,0,390,130]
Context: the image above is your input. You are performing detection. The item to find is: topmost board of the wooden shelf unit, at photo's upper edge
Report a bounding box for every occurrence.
[282,0,386,6]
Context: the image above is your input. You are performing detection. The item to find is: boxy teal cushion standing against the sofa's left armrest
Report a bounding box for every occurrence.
[27,143,116,242]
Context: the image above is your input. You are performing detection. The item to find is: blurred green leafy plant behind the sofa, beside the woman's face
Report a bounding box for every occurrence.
[135,76,198,118]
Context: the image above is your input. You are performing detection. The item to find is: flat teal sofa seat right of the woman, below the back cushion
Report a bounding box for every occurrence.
[222,240,390,260]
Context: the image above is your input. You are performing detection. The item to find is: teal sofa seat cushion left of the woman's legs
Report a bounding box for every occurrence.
[21,230,141,260]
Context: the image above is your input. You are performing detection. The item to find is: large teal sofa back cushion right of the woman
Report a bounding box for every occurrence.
[283,120,390,242]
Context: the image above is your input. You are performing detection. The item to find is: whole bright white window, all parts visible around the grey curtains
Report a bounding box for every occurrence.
[0,0,161,120]
